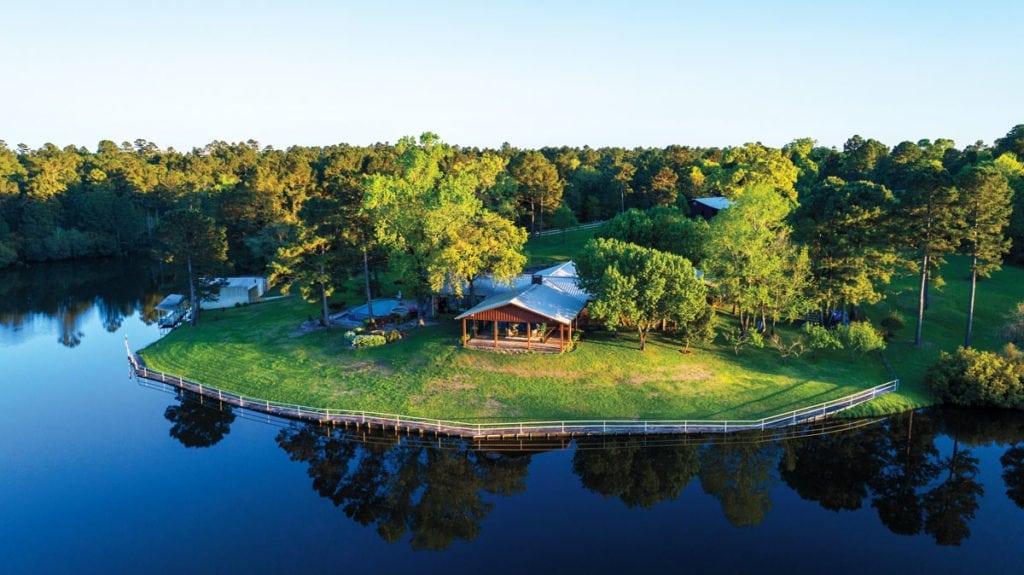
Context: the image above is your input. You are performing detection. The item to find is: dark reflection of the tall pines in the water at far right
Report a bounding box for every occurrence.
[781,409,1024,545]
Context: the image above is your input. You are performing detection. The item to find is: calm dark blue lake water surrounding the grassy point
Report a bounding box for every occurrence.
[0,262,1024,574]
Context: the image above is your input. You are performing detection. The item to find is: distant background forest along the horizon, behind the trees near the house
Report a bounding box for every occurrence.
[0,129,1024,266]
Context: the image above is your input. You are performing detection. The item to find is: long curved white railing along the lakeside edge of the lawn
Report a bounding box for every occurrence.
[125,340,899,438]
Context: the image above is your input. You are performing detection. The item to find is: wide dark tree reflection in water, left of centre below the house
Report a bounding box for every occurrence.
[276,425,529,549]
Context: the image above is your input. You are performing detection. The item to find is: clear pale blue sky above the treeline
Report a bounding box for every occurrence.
[0,0,1024,149]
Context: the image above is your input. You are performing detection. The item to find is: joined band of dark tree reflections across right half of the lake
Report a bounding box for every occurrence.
[572,409,1024,545]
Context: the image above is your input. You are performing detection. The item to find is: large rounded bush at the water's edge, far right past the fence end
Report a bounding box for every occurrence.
[927,347,1024,408]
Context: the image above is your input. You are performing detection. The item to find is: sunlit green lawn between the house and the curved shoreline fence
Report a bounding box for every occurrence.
[141,290,889,423]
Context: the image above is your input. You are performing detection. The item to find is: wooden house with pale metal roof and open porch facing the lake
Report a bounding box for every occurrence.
[456,262,590,353]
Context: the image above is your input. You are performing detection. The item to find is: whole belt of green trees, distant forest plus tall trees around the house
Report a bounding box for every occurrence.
[0,125,1024,333]
